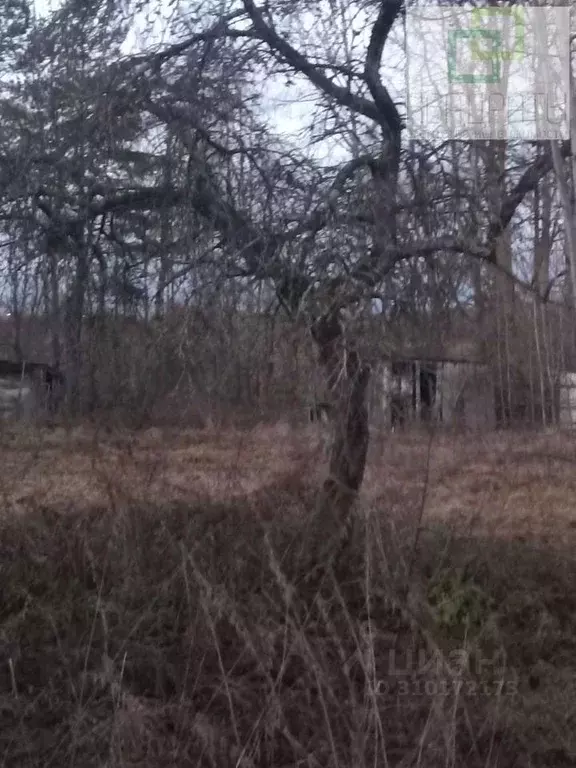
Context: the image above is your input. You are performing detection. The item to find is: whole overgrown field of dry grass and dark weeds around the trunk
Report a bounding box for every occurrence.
[0,425,576,768]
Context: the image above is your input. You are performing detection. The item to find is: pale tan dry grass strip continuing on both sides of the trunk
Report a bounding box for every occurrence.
[0,424,576,545]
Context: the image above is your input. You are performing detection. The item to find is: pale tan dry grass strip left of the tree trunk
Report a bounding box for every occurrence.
[0,425,314,511]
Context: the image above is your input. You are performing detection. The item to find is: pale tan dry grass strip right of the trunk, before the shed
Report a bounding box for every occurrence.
[365,426,576,546]
